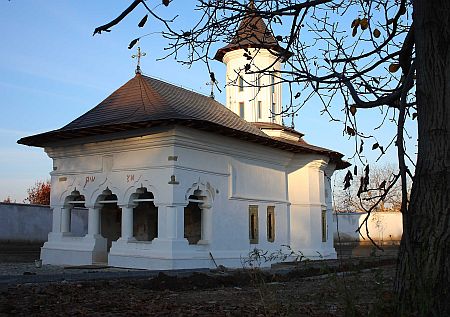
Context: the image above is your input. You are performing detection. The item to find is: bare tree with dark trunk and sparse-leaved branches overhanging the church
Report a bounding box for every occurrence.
[94,0,450,316]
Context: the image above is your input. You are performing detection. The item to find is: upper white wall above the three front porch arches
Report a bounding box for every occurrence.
[46,128,178,205]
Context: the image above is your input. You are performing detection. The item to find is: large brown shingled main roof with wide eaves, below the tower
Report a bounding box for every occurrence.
[17,74,347,168]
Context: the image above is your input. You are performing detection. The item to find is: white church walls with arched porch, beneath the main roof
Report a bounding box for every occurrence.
[44,127,331,269]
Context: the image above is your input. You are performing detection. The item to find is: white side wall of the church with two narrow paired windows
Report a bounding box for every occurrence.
[171,128,292,262]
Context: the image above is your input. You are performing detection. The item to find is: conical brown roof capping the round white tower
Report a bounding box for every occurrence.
[214,1,291,62]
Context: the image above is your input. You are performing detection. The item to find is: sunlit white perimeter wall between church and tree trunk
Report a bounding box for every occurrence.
[333,212,403,242]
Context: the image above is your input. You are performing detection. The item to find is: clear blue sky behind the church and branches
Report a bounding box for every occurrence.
[0,0,416,202]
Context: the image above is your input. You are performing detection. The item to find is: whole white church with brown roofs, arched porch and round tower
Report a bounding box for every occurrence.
[18,6,348,270]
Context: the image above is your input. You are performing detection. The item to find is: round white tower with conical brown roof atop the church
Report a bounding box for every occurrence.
[214,1,291,125]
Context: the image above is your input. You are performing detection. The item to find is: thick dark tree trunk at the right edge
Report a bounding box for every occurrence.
[395,0,450,316]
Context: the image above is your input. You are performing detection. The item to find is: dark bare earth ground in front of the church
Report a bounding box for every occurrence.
[0,256,395,316]
